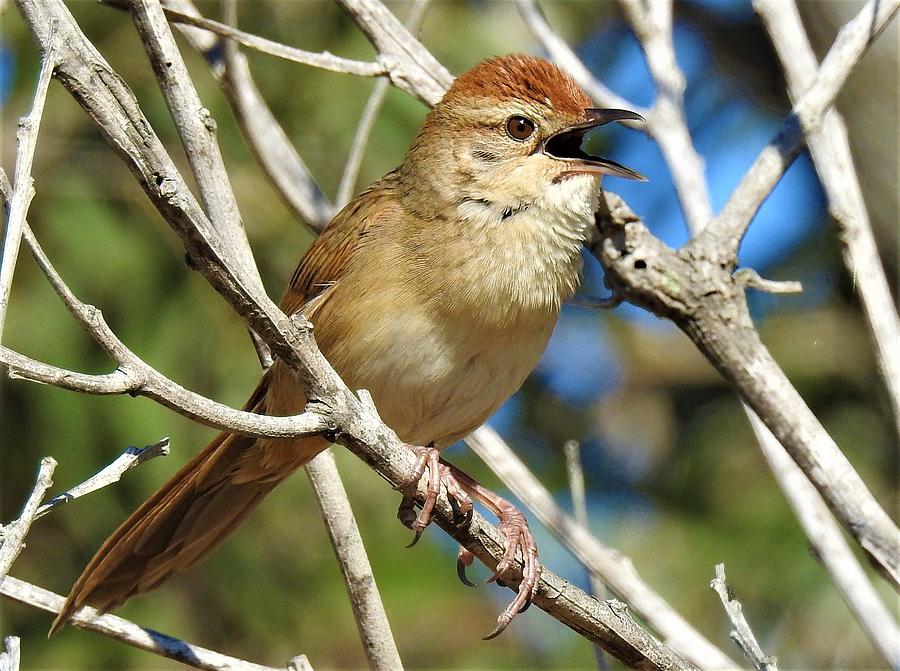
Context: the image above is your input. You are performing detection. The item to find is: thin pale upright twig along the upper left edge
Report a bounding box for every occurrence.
[0,25,57,342]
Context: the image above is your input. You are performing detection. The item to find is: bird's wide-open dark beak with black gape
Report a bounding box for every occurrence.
[538,107,647,182]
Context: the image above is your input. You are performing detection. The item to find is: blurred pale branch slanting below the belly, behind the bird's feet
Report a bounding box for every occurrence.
[466,425,737,669]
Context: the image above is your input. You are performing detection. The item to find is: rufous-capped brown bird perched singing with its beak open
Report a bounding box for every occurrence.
[50,55,643,637]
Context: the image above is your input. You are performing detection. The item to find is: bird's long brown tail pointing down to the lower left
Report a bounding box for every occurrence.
[50,385,328,635]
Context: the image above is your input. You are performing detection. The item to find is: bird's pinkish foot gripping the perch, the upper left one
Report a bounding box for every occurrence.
[396,445,474,547]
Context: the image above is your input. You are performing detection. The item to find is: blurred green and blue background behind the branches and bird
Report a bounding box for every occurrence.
[0,0,898,670]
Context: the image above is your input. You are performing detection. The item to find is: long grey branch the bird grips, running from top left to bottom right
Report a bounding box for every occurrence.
[7,0,690,668]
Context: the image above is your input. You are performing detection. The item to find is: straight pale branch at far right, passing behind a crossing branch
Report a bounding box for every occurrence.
[753,0,900,434]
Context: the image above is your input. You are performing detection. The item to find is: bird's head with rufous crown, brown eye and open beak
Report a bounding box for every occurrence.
[401,56,644,218]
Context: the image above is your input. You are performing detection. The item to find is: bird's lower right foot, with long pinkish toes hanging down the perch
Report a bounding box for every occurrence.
[457,494,541,640]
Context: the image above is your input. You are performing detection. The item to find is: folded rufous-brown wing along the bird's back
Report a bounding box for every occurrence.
[281,172,397,315]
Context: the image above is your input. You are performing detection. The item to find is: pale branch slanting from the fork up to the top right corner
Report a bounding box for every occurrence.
[704,0,900,259]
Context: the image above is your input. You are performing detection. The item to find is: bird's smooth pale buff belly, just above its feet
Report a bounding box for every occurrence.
[317,284,555,447]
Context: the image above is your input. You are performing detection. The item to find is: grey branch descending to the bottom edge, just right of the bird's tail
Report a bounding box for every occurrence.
[305,450,403,670]
